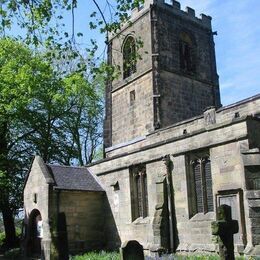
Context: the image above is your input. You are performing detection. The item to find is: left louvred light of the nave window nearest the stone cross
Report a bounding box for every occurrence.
[193,162,204,212]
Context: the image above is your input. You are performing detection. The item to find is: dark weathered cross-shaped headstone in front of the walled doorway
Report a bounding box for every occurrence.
[211,205,238,260]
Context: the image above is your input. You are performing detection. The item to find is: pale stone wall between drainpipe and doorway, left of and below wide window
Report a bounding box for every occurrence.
[172,155,215,251]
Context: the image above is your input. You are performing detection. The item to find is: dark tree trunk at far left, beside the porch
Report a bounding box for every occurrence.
[2,206,18,249]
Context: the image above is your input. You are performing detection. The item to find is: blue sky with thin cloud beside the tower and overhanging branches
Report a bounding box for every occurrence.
[71,0,260,105]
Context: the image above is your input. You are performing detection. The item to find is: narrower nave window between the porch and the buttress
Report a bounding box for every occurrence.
[130,164,148,221]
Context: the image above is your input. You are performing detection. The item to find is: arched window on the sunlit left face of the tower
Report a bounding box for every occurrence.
[123,36,136,79]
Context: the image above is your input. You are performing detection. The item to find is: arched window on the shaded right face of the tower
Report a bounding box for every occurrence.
[180,32,196,72]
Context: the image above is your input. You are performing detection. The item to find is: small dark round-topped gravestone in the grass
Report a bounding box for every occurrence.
[120,240,144,260]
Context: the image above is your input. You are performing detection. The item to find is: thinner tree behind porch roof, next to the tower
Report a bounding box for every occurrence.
[63,73,104,165]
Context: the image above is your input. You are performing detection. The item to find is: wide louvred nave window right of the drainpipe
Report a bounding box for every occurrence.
[188,154,214,217]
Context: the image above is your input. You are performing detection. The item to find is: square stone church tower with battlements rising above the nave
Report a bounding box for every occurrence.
[104,0,221,151]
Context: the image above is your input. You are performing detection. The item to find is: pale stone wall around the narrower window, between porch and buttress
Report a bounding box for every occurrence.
[96,161,170,250]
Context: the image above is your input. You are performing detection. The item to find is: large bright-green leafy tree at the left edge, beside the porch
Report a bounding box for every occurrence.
[0,39,56,247]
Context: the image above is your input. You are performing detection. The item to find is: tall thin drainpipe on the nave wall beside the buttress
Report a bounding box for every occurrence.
[163,155,174,252]
